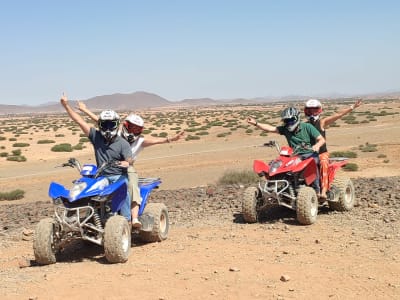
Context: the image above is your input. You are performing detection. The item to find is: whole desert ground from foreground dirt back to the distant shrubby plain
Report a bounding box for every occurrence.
[0,101,400,299]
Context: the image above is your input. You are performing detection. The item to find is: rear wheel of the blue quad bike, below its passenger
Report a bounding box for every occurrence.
[139,203,169,243]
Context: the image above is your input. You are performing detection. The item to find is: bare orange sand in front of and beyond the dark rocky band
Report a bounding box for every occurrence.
[0,103,400,299]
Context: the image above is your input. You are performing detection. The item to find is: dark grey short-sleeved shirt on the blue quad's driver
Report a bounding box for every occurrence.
[89,127,132,176]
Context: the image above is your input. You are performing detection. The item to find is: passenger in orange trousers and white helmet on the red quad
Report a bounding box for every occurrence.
[304,99,362,200]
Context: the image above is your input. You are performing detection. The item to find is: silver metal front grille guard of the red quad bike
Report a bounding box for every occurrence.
[258,179,296,209]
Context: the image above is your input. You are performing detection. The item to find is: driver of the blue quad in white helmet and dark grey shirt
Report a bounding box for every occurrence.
[60,94,133,222]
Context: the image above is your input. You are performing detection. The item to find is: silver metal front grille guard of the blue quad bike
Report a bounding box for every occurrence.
[54,205,104,245]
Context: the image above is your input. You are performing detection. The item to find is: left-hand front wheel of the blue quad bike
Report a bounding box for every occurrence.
[33,218,56,265]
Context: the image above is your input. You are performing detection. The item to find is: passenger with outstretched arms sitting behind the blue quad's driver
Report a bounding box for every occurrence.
[78,101,185,228]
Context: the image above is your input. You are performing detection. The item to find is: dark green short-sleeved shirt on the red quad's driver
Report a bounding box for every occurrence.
[277,122,321,154]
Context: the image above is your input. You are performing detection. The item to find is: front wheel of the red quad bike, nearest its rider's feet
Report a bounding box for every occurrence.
[296,186,318,225]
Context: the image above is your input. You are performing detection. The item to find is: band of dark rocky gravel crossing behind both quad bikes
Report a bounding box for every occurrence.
[0,177,400,238]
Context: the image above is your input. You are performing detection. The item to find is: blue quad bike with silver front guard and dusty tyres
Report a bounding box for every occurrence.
[33,158,169,265]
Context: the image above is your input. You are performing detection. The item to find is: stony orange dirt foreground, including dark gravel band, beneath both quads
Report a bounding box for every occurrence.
[0,177,400,299]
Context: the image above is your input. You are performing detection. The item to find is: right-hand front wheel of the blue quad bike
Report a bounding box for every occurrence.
[104,216,131,263]
